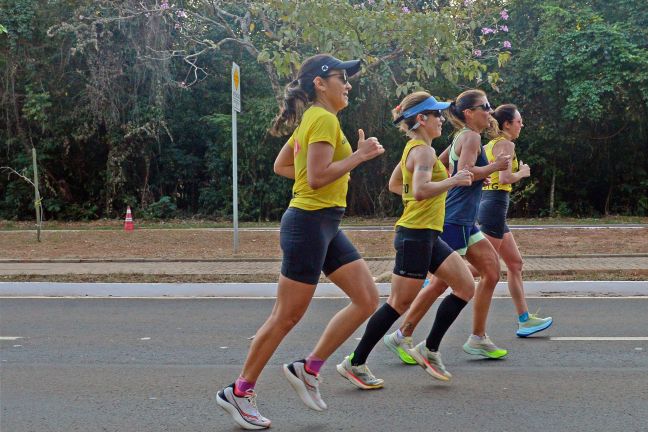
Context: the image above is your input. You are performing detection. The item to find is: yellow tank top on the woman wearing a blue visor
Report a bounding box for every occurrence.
[396,140,448,231]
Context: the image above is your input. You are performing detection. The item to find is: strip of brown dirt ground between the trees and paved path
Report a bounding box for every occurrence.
[0,228,648,260]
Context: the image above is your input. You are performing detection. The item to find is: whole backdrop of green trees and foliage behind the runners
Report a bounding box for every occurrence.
[0,0,648,221]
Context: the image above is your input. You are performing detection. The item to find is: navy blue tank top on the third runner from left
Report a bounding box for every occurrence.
[445,128,488,225]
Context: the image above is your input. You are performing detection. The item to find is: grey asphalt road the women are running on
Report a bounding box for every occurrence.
[0,297,648,432]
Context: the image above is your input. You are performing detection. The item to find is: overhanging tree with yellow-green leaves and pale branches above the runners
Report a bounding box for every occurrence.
[107,0,508,101]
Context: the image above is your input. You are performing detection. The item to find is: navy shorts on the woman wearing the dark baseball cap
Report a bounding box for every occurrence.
[279,207,362,285]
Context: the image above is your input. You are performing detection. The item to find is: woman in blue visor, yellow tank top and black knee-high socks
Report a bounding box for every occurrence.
[337,92,474,390]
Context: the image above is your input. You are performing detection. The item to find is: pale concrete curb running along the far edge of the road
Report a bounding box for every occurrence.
[0,281,648,298]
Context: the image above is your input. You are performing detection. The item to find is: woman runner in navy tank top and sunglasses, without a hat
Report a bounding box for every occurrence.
[392,89,511,363]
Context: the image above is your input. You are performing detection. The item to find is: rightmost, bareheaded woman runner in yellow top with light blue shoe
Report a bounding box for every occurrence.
[477,104,553,337]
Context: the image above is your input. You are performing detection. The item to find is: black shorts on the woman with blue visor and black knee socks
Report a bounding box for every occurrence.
[394,226,453,279]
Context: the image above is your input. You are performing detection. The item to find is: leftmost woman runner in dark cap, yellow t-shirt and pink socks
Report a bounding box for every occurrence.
[216,54,385,429]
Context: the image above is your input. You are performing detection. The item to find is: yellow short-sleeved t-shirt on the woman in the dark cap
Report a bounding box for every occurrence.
[288,106,353,210]
